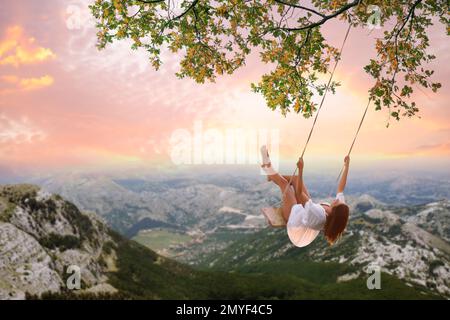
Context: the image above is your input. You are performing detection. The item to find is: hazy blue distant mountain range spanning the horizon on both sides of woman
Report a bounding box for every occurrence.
[32,169,450,236]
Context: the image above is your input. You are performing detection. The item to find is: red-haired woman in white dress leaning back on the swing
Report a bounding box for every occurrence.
[261,146,350,247]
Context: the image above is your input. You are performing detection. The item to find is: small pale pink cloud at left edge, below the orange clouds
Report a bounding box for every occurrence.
[0,114,46,144]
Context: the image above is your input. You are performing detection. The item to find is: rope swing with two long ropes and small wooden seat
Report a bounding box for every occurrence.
[261,23,372,228]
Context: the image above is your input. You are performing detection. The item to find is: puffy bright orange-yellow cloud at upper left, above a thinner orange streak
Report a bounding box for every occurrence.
[0,26,56,67]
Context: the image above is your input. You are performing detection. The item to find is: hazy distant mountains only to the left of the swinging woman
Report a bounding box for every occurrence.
[38,174,270,235]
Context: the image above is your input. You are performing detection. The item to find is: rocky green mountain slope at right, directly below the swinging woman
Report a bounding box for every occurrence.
[196,196,450,299]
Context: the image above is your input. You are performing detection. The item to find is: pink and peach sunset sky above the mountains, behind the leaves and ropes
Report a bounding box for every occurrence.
[0,0,450,175]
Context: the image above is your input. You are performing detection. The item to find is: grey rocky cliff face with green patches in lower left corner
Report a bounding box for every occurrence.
[0,185,115,299]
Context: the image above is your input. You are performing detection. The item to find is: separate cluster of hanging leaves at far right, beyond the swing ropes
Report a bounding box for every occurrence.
[364,0,449,120]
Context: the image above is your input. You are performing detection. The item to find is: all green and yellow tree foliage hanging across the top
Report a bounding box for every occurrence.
[91,0,449,119]
